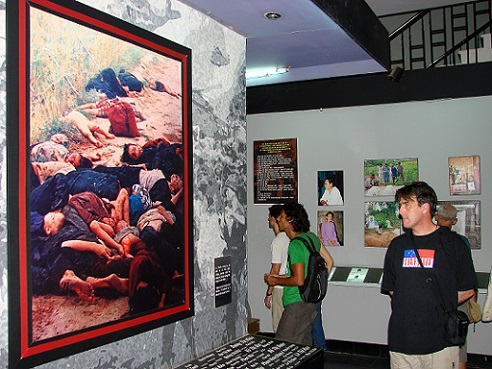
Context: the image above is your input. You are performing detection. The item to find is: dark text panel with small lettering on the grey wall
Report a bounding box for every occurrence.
[253,138,299,204]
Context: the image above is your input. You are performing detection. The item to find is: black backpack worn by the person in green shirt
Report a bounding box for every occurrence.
[294,237,328,303]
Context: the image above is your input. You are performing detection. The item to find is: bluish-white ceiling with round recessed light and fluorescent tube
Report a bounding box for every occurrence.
[176,0,472,87]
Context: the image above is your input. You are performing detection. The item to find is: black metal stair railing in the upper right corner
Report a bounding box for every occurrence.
[380,0,492,70]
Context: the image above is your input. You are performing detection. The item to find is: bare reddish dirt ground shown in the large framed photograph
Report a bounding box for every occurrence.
[32,53,183,341]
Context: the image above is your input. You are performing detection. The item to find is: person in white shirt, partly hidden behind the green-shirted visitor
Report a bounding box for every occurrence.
[264,205,290,333]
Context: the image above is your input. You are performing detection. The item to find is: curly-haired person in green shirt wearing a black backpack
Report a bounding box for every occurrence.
[264,203,333,346]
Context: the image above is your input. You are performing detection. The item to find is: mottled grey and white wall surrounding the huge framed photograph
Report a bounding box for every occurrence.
[0,0,247,369]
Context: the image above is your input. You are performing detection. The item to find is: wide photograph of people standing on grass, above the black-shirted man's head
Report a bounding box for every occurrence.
[364,158,419,196]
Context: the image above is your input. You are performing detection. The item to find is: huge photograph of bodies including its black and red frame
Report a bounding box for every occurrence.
[7,0,194,368]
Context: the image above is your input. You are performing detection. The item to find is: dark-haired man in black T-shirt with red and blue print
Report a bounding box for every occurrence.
[381,182,477,369]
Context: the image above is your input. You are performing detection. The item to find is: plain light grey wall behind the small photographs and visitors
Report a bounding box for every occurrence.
[247,96,492,354]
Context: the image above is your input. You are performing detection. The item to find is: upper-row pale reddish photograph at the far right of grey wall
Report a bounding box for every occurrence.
[448,156,480,195]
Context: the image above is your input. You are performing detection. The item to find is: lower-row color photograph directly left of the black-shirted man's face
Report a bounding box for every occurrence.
[364,201,402,247]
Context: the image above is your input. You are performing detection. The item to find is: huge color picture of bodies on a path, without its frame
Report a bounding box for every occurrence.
[27,4,190,342]
